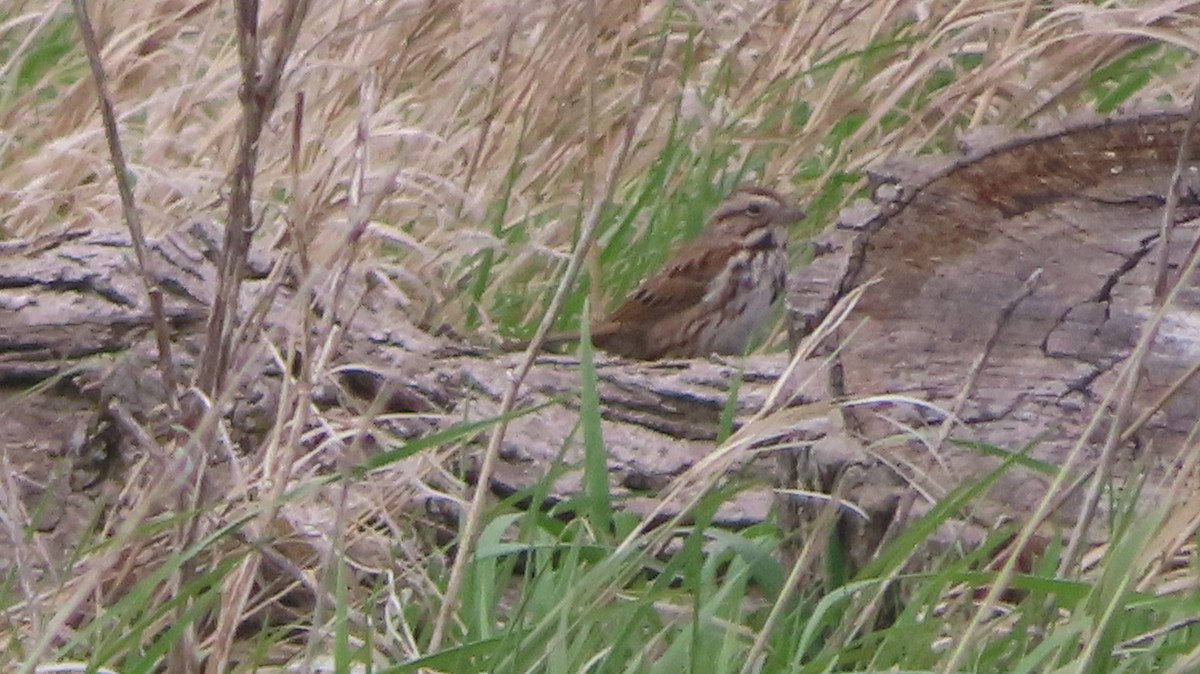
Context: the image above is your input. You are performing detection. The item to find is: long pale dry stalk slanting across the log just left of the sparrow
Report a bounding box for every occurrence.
[430,34,666,651]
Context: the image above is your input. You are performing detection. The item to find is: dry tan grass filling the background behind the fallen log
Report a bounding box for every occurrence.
[0,0,1195,325]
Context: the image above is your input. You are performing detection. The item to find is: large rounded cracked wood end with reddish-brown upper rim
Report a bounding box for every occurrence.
[791,113,1200,566]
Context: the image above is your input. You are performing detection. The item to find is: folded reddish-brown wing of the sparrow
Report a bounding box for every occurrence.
[608,241,733,324]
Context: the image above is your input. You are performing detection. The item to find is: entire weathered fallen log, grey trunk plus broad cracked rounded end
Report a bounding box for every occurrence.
[0,113,1200,570]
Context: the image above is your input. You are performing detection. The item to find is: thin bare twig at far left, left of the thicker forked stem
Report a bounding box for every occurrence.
[73,0,175,411]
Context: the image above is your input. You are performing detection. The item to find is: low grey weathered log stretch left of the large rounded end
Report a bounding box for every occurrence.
[0,222,806,570]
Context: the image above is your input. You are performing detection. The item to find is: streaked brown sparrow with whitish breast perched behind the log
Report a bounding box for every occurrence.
[551,187,804,360]
